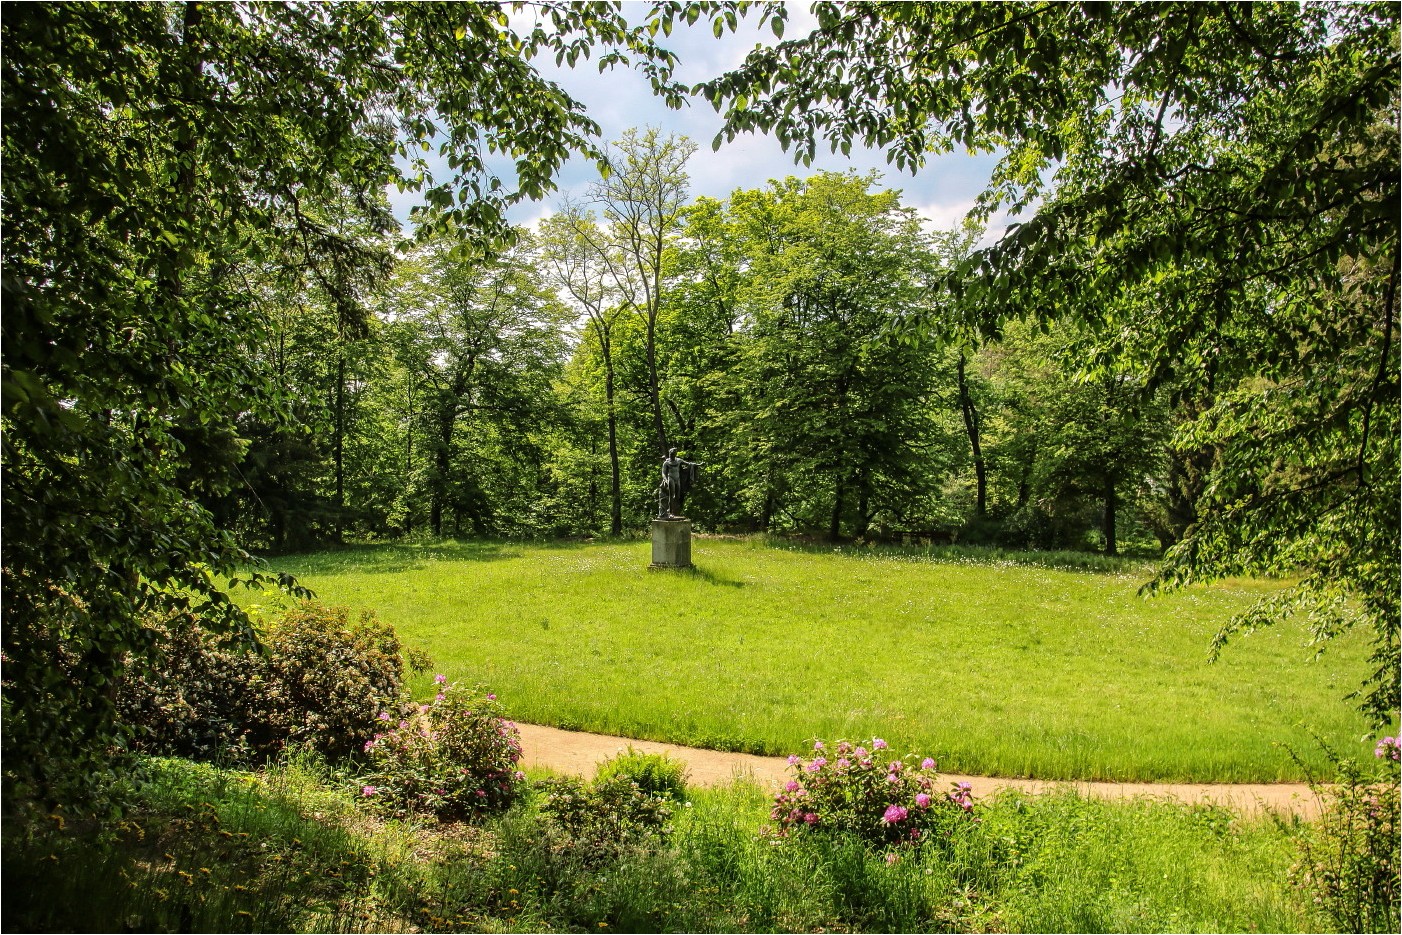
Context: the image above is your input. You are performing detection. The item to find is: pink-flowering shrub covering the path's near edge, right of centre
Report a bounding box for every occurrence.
[770,737,973,845]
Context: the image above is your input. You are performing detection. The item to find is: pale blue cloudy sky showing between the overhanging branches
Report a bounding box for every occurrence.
[390,3,1008,241]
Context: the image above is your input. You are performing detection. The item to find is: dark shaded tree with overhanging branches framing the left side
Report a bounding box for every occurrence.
[0,1,680,795]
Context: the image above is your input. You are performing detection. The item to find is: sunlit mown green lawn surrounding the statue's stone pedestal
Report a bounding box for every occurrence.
[255,538,1371,781]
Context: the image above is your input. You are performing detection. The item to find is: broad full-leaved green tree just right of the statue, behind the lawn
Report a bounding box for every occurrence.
[721,174,932,540]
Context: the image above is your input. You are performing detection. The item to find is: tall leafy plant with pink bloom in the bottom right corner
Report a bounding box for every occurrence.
[1290,737,1402,932]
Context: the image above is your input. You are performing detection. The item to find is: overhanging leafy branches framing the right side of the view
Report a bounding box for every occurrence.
[695,3,1402,723]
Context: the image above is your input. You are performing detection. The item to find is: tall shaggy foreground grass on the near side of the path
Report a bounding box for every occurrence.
[3,761,1321,932]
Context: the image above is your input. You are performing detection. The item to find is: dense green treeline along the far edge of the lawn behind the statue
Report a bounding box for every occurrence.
[227,164,1185,552]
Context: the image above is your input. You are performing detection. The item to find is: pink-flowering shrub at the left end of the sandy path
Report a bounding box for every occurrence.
[360,676,526,820]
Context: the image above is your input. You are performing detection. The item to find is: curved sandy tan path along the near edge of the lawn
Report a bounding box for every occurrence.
[516,723,1319,819]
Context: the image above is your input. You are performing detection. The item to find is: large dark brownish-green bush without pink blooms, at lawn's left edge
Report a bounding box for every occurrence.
[116,603,404,763]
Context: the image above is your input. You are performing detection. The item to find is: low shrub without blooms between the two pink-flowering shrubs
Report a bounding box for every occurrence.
[537,775,672,865]
